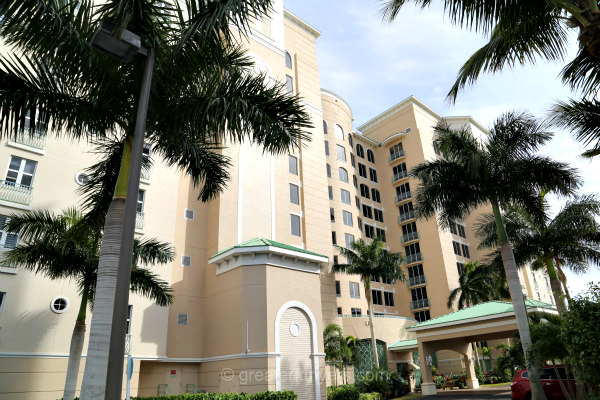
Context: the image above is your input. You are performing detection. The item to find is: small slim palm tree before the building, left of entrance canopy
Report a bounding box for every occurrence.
[333,237,406,368]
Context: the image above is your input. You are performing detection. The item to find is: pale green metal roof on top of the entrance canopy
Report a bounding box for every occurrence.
[407,298,556,329]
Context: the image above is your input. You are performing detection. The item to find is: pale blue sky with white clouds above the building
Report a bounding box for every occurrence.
[284,0,600,294]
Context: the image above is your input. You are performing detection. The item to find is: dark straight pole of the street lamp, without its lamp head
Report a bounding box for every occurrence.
[105,48,154,400]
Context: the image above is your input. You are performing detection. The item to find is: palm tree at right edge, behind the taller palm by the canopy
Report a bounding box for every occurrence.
[476,195,600,314]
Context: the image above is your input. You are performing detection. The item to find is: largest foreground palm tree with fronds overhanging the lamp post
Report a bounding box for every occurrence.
[0,0,310,398]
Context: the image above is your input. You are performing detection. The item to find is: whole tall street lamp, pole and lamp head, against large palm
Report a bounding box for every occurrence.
[91,21,154,400]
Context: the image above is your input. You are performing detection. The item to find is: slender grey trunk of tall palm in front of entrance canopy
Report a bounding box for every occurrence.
[491,201,546,400]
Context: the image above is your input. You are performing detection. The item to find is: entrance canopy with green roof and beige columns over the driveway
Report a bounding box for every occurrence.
[389,299,557,396]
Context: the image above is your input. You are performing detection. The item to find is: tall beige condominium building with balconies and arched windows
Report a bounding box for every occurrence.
[0,0,551,400]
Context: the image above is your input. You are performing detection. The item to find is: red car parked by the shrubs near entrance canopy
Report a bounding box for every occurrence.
[510,365,575,400]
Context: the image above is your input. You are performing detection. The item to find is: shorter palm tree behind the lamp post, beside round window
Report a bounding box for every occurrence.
[2,208,174,400]
